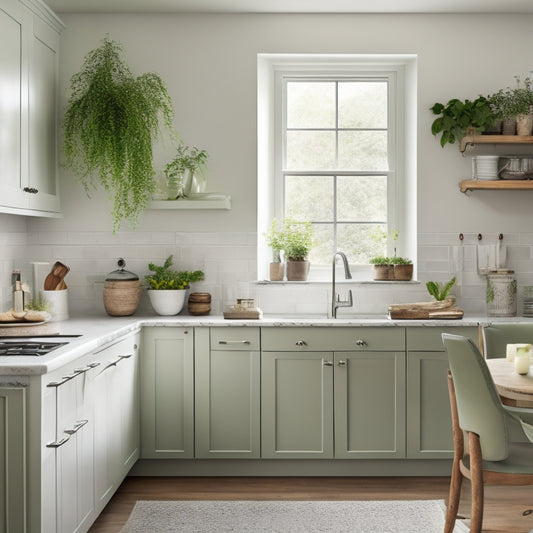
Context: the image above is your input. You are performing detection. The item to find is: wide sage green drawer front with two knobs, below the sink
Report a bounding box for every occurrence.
[261,327,405,351]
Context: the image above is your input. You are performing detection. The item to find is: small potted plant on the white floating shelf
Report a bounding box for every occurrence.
[163,143,209,200]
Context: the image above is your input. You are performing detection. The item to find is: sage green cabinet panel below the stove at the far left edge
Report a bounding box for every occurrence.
[0,388,26,533]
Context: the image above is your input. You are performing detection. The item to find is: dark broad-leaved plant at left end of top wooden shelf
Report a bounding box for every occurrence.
[430,95,494,147]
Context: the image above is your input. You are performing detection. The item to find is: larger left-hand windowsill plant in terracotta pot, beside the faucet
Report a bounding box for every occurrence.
[282,218,313,281]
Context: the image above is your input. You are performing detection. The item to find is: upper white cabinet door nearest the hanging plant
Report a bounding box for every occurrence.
[27,17,59,213]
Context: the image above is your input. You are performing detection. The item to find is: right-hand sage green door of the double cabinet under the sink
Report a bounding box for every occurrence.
[335,352,405,459]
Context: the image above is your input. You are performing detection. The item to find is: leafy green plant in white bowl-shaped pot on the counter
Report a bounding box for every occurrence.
[144,255,204,316]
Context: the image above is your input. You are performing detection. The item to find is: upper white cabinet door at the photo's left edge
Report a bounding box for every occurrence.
[0,0,32,208]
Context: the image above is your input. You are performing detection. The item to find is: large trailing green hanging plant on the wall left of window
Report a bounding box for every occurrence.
[63,37,174,232]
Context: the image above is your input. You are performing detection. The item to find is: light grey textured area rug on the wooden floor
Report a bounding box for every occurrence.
[121,500,468,533]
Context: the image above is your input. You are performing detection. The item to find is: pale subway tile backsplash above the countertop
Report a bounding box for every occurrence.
[0,222,533,317]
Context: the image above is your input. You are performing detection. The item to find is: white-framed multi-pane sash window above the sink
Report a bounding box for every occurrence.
[258,55,416,279]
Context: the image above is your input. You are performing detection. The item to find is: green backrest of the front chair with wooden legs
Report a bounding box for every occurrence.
[442,333,509,461]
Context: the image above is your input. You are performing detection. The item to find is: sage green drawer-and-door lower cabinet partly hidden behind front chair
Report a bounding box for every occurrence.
[406,326,478,459]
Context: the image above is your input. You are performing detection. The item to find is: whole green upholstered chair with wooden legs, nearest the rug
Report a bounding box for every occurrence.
[442,333,533,533]
